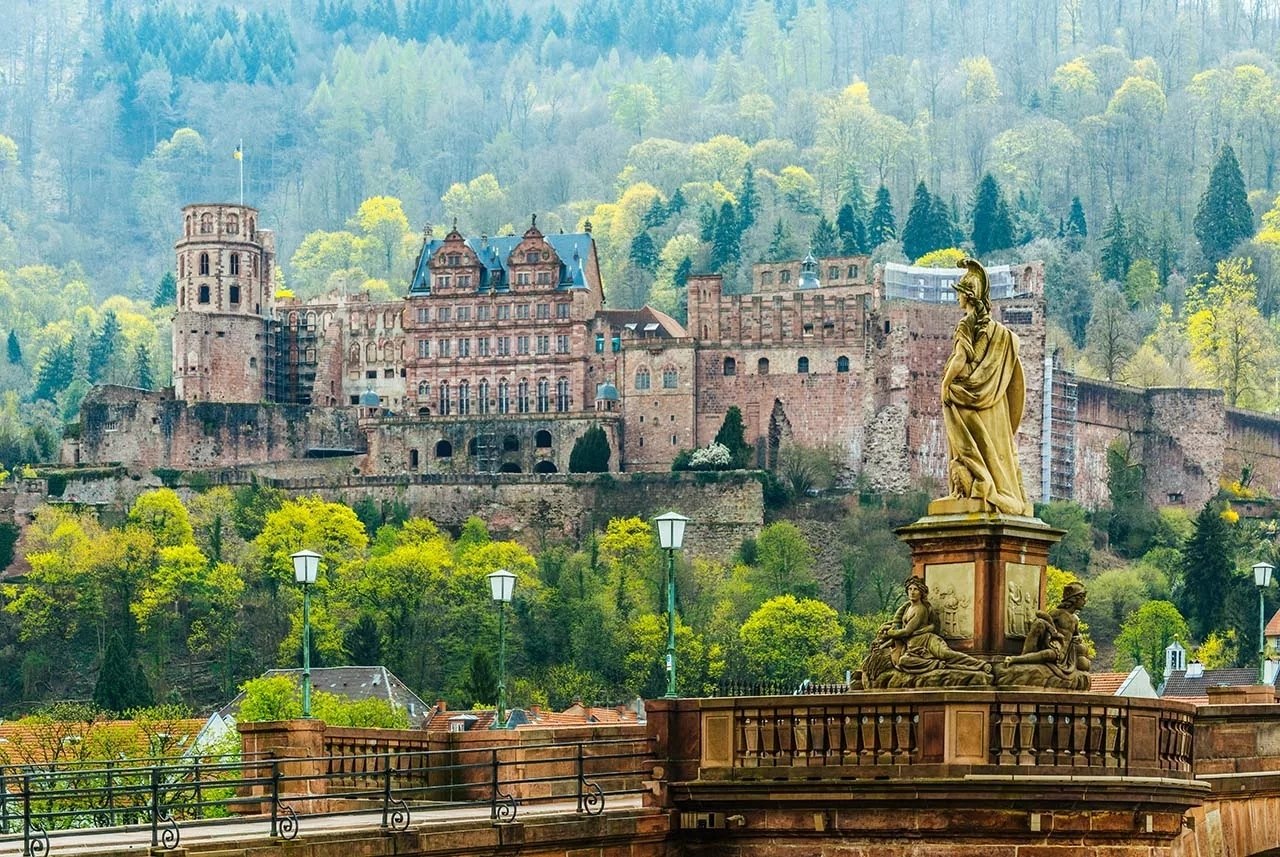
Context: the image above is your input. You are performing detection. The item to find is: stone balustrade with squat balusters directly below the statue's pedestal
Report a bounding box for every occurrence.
[665,691,1194,780]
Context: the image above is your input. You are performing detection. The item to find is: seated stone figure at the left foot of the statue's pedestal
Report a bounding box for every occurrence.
[863,576,991,688]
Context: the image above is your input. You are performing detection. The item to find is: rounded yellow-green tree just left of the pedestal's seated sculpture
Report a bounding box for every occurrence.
[739,595,844,687]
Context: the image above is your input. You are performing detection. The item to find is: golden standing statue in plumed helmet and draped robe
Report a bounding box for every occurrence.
[929,258,1032,515]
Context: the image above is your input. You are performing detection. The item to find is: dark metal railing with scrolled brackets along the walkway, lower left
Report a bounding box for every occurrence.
[0,738,653,857]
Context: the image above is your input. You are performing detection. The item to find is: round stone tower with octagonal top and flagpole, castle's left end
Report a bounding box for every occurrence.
[173,203,275,402]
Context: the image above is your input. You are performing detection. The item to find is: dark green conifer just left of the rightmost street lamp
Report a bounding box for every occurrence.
[1178,500,1235,640]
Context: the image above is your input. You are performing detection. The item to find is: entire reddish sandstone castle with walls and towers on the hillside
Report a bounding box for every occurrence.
[64,203,1280,514]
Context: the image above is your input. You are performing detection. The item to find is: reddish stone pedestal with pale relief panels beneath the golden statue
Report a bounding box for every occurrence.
[897,514,1065,655]
